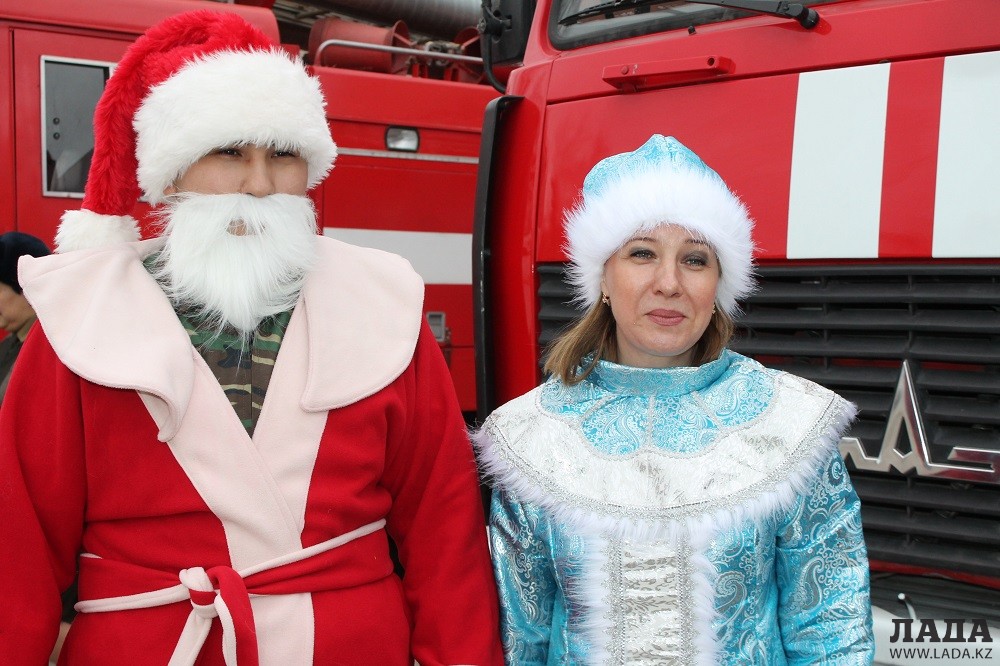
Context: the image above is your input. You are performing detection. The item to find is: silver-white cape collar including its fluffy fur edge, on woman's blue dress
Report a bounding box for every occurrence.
[472,373,857,541]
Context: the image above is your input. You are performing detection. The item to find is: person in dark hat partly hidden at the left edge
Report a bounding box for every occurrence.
[0,231,49,402]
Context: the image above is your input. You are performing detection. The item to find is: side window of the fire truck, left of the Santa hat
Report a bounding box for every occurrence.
[42,56,114,197]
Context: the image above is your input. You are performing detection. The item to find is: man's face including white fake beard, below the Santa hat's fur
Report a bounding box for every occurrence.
[154,145,316,333]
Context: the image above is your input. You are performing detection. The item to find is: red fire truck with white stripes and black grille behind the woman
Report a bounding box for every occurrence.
[474,0,1000,648]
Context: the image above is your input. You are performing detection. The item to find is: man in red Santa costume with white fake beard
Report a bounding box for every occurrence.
[0,11,502,666]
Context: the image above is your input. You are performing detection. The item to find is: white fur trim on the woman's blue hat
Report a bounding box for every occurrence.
[565,167,754,315]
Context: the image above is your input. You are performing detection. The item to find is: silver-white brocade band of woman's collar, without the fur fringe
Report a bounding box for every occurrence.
[485,374,852,521]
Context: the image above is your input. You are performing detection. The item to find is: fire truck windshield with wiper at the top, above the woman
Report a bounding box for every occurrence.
[549,0,837,49]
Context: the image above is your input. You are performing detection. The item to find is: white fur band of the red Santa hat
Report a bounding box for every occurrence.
[133,49,337,205]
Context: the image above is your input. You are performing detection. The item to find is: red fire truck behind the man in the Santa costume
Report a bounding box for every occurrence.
[0,0,497,411]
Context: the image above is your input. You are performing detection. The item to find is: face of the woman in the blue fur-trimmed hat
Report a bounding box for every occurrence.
[601,224,719,368]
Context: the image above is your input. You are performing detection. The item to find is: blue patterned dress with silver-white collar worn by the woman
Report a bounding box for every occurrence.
[476,351,874,666]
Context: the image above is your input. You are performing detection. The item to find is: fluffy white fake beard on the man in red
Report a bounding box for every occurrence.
[153,193,317,339]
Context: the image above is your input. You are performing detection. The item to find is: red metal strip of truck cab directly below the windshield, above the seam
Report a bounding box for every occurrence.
[544,0,997,103]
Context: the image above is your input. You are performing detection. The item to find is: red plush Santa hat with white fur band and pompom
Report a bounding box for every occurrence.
[56,10,337,252]
